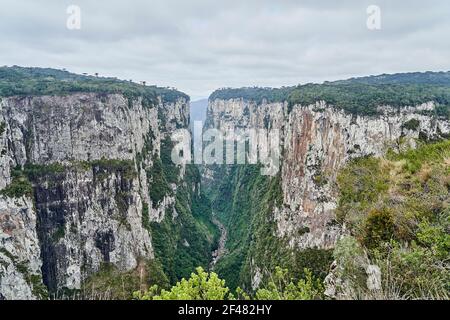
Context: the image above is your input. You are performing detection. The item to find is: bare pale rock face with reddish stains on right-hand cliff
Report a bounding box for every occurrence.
[207,99,450,285]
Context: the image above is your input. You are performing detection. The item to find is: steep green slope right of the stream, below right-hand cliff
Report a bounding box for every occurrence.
[212,165,277,289]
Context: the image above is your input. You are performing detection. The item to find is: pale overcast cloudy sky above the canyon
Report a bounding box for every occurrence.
[0,0,450,100]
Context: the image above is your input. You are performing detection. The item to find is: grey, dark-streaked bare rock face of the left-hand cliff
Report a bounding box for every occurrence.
[0,93,194,299]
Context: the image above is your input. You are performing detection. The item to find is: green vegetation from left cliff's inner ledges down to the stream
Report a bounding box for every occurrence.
[145,141,219,284]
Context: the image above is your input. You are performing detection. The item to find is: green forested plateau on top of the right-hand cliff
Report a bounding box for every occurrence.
[210,72,450,119]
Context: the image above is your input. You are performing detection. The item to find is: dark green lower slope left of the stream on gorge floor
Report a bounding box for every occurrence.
[150,165,219,283]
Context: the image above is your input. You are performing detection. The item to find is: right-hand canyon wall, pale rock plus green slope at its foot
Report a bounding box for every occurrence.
[204,80,450,288]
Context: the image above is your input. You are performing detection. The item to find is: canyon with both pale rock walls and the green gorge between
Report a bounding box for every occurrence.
[0,69,450,300]
